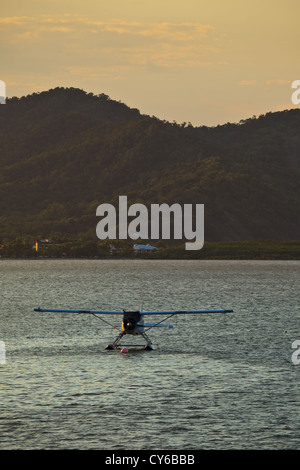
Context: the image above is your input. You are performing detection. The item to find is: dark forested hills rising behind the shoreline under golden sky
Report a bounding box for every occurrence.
[0,88,300,241]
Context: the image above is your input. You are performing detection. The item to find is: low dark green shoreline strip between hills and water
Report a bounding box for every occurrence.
[0,239,300,261]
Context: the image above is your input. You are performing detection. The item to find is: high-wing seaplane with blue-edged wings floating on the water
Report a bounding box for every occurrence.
[34,305,233,352]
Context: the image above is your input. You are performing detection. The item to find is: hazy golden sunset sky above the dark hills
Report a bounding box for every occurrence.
[0,0,300,126]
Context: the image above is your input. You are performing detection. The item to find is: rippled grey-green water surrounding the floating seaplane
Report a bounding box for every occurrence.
[0,260,300,450]
